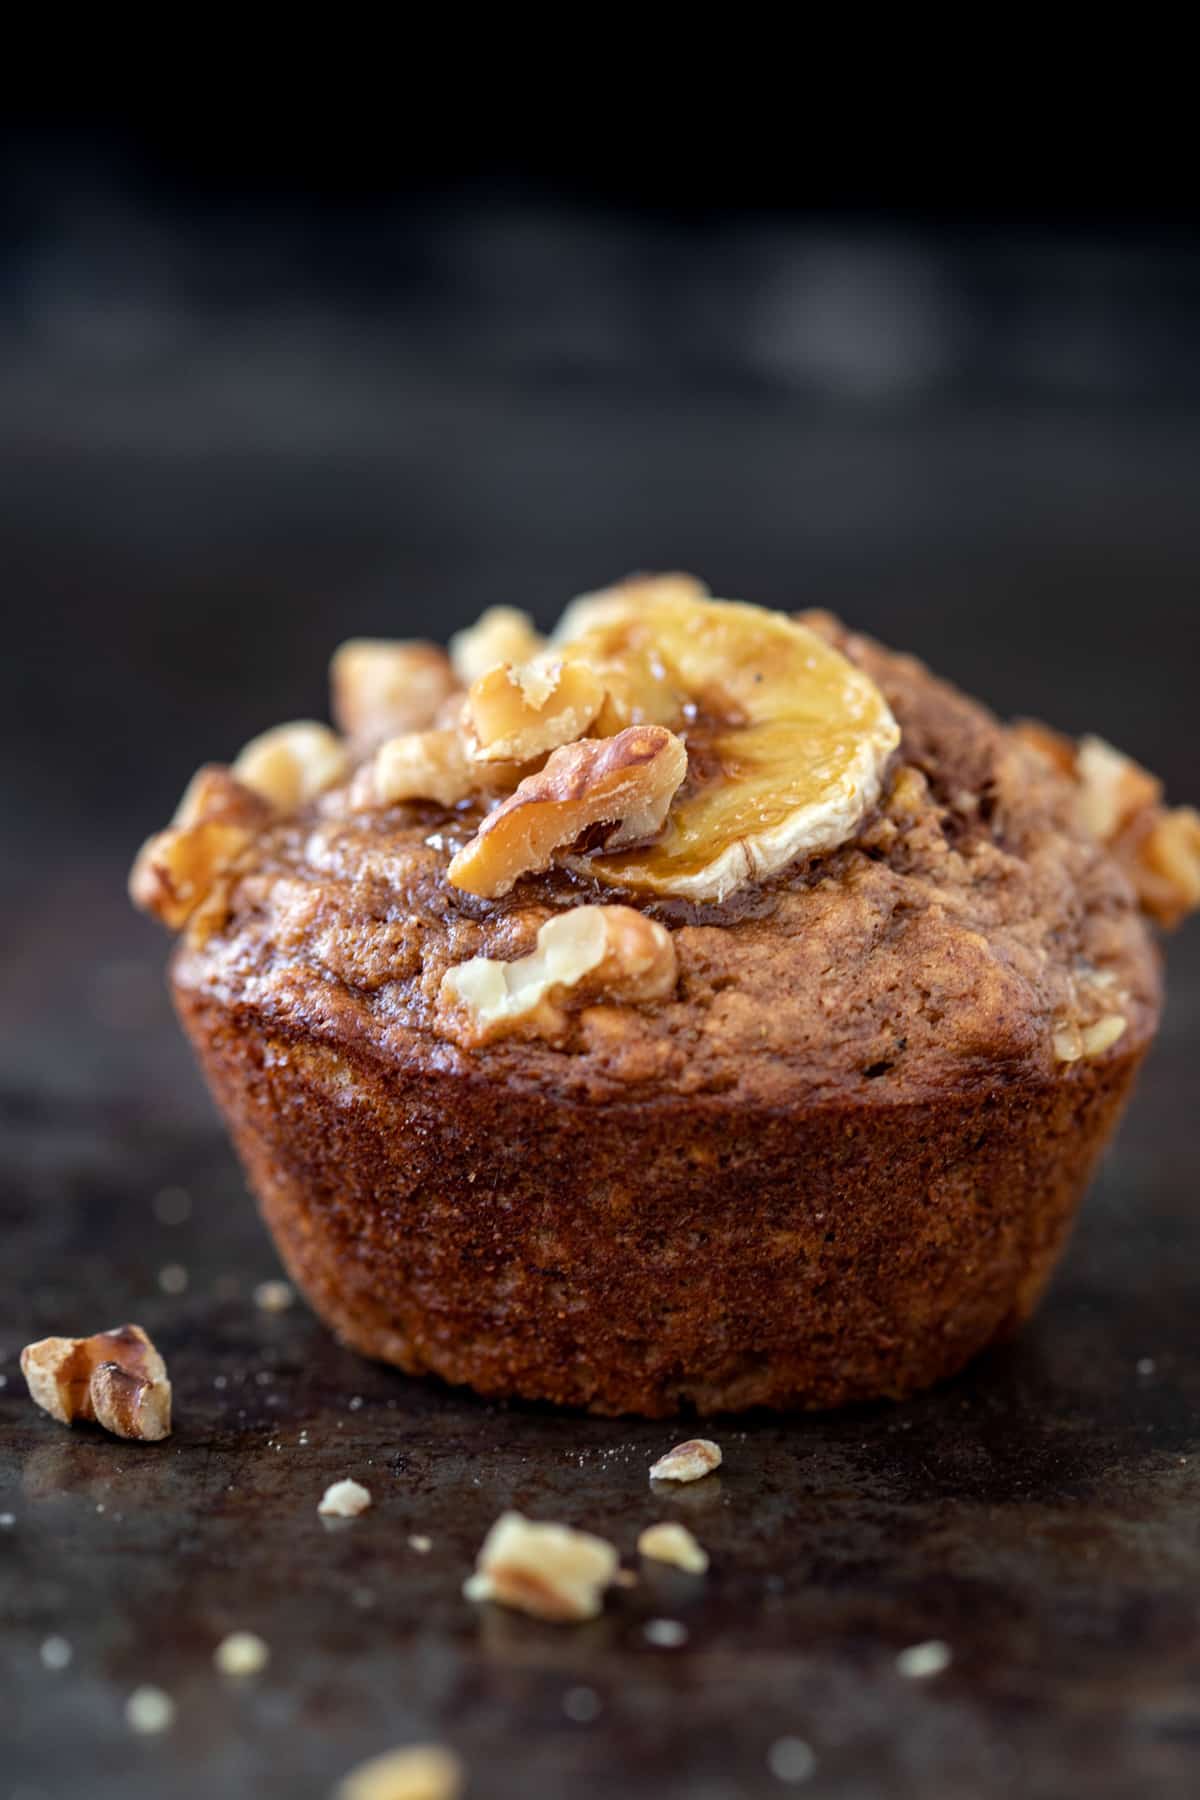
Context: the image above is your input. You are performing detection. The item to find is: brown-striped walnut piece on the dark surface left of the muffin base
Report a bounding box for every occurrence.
[22,1325,171,1444]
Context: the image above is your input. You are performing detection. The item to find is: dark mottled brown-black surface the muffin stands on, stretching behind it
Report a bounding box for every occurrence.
[0,394,1200,1800]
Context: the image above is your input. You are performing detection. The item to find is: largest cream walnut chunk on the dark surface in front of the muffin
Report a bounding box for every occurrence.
[462,1512,617,1624]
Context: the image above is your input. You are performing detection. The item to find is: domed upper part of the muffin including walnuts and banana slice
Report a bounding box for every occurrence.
[133,578,1200,1107]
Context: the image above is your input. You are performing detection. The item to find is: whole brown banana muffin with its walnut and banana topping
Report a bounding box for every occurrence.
[131,576,1200,1417]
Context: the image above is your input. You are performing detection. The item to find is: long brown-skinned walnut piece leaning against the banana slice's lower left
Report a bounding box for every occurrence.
[446,725,687,900]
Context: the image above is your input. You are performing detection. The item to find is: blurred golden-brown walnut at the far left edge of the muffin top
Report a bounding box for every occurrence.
[130,763,272,931]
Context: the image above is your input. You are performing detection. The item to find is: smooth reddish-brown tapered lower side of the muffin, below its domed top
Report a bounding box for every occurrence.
[175,981,1148,1417]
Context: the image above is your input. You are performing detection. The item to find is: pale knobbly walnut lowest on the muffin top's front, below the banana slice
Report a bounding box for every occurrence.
[439,905,676,1049]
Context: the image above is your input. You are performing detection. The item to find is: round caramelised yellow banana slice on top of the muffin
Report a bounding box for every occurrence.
[560,578,900,900]
